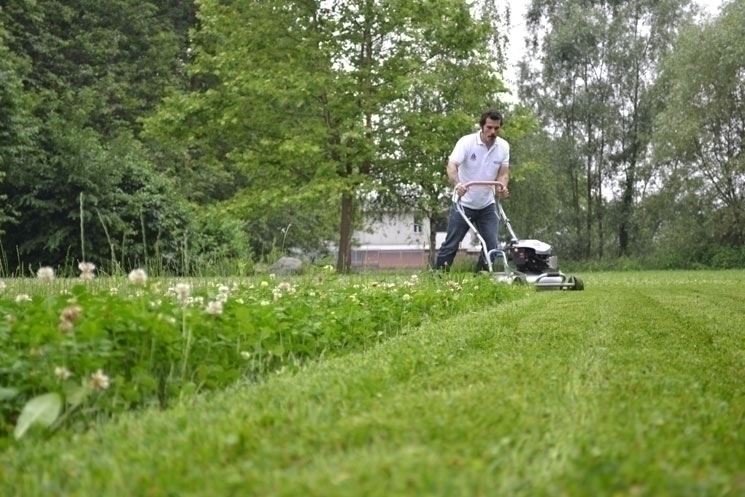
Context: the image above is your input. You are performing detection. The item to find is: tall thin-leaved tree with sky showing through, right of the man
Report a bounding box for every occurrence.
[521,0,690,257]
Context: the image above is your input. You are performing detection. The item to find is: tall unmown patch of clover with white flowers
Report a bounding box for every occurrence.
[0,266,519,445]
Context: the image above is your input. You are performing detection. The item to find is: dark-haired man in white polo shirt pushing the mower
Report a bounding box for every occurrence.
[435,110,510,270]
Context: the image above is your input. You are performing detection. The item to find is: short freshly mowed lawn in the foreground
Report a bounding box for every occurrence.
[0,272,745,496]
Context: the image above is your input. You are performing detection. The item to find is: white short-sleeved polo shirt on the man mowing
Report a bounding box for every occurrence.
[450,131,510,209]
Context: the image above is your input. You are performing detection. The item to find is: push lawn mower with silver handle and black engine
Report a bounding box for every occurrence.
[453,181,585,290]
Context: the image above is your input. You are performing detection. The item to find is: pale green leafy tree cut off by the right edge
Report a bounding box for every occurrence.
[654,1,745,246]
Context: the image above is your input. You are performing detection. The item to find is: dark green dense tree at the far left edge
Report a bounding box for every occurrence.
[0,0,201,267]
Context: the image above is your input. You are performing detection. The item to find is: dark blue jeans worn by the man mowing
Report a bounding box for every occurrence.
[435,203,499,271]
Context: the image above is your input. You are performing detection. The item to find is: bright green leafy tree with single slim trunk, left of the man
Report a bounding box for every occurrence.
[150,0,506,271]
